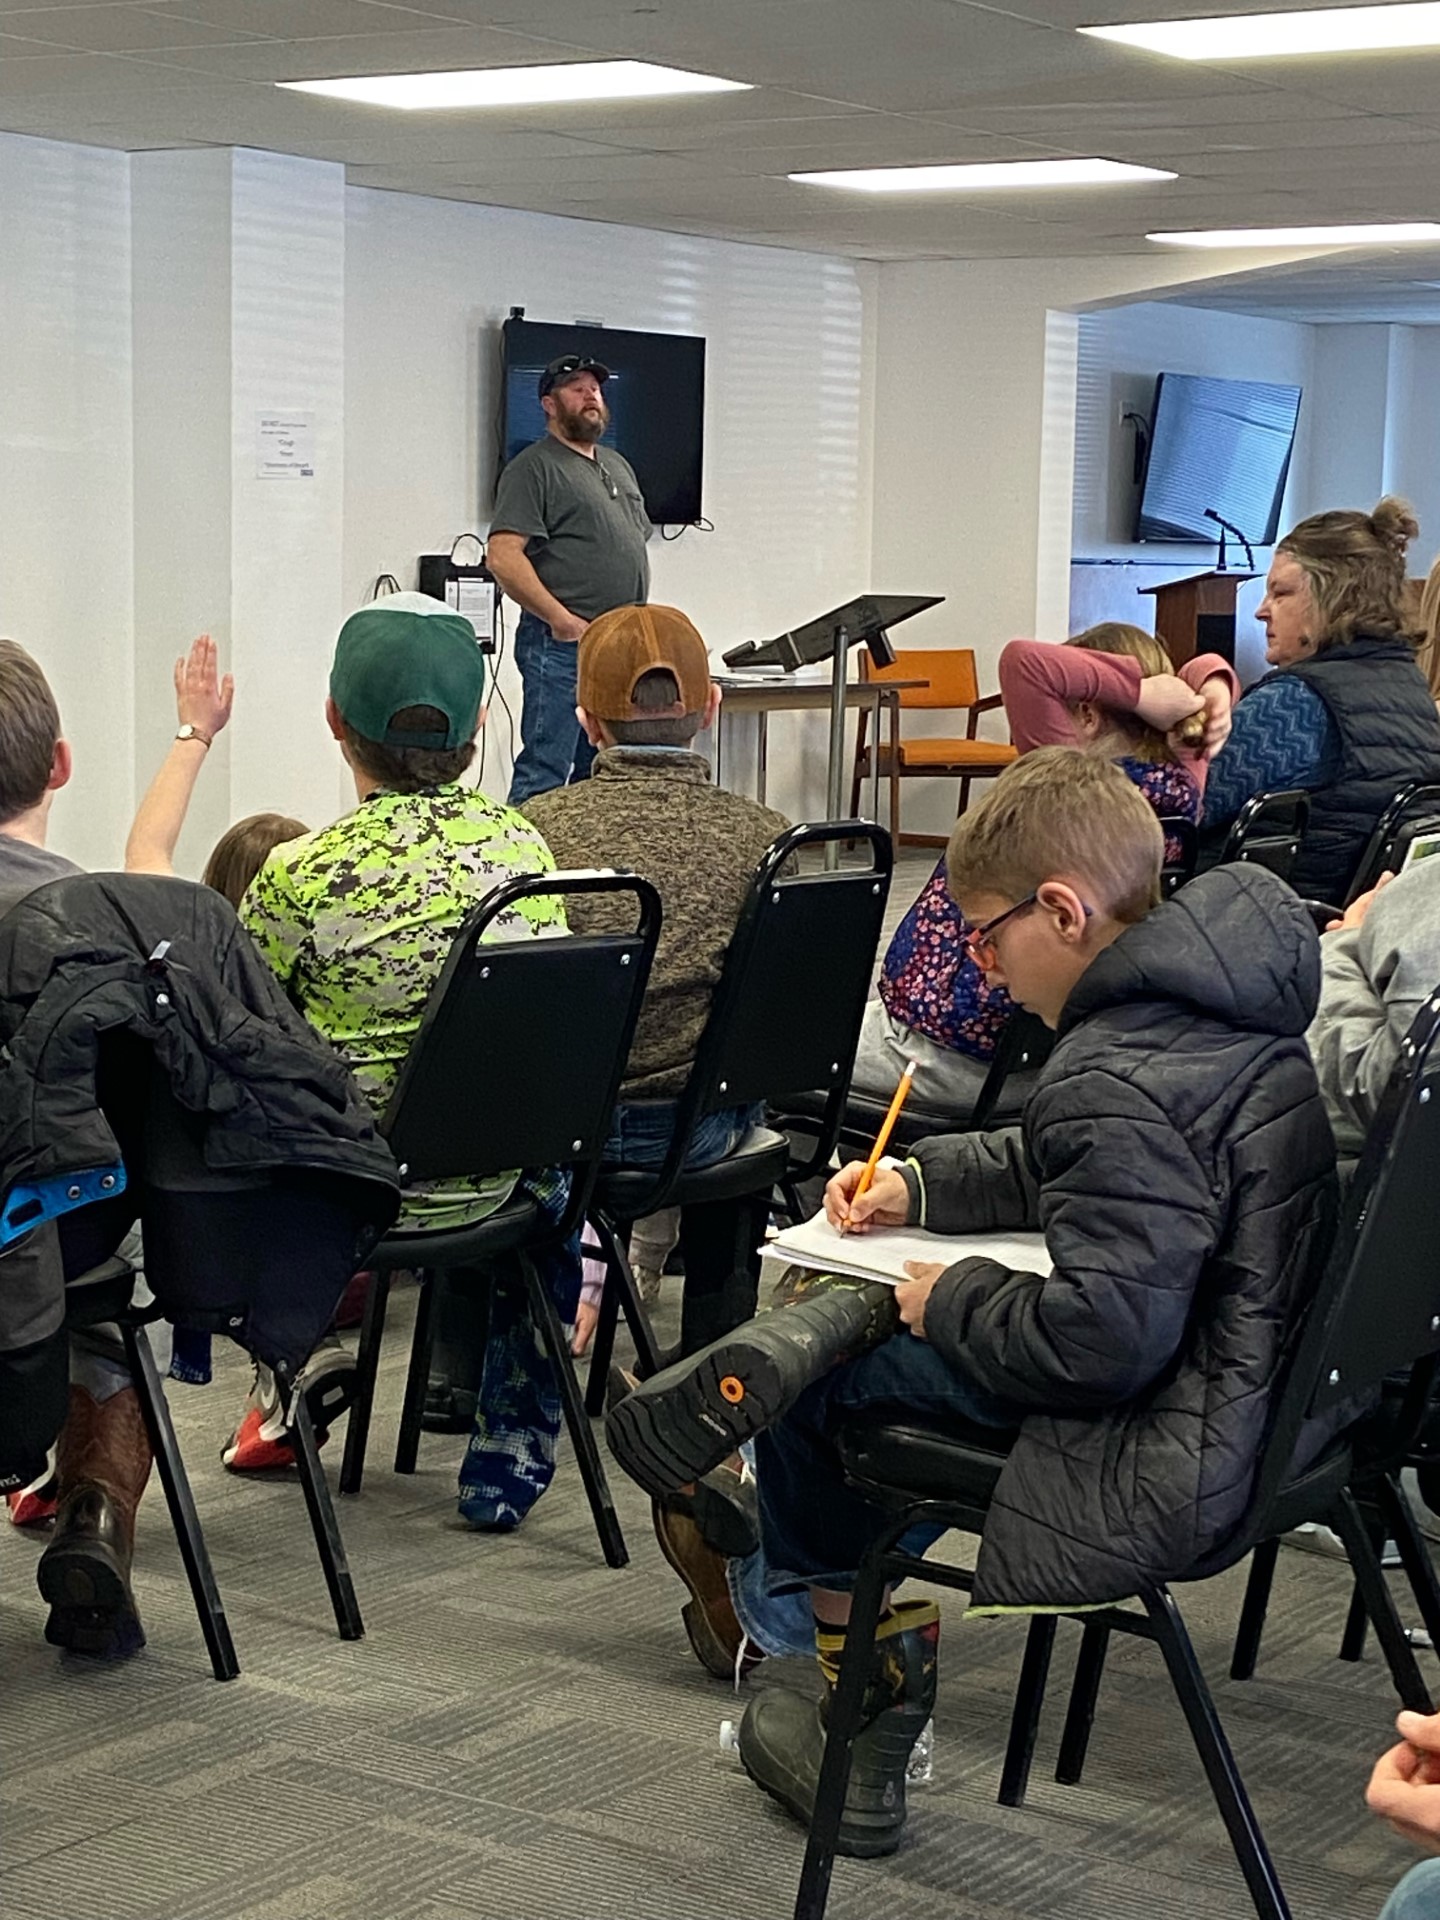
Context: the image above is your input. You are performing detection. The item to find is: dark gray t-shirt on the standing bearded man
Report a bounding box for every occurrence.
[490,434,653,620]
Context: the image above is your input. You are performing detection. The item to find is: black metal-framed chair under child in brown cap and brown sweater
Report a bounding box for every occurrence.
[586,820,893,1413]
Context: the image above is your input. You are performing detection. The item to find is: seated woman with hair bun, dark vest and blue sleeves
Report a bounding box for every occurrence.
[1204,493,1440,900]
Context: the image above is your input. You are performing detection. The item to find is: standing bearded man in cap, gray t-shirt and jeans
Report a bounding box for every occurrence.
[486,353,653,806]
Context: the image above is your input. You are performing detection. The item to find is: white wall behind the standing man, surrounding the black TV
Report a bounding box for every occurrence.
[344,190,876,816]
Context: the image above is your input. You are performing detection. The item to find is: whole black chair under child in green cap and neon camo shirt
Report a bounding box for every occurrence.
[340,874,660,1567]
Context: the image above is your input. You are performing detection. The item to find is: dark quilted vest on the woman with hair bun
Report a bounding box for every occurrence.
[1261,634,1440,902]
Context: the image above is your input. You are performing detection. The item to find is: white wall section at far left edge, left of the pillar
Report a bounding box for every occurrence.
[0,138,134,866]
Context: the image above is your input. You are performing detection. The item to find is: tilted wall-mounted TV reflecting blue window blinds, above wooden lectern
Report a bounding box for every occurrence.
[1135,372,1300,547]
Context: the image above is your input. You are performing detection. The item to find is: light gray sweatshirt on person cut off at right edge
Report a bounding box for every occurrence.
[1309,856,1440,1158]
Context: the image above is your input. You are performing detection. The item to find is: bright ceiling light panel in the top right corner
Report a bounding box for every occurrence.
[1079,0,1440,60]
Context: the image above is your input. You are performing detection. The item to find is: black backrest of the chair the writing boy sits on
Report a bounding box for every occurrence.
[1258,991,1440,1509]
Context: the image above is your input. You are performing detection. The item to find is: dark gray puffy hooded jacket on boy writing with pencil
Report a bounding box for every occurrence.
[906,866,1336,1607]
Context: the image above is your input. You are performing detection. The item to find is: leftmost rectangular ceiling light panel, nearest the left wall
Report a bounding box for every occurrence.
[276,60,749,113]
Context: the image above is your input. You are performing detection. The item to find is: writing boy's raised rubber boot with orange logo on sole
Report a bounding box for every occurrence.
[605,1267,900,1500]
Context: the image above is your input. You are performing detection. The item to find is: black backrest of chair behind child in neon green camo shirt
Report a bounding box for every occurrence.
[380,874,660,1231]
